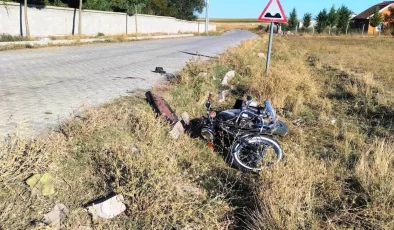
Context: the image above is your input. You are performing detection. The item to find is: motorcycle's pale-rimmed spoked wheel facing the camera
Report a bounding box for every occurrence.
[230,135,283,172]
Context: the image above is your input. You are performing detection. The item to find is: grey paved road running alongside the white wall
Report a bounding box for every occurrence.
[0,31,256,136]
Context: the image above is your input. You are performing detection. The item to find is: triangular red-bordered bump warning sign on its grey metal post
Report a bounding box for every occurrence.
[258,0,287,76]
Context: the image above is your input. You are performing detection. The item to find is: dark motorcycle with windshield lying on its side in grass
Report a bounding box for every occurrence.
[200,94,288,172]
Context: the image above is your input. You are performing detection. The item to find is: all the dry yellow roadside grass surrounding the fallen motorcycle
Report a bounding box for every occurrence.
[0,36,394,229]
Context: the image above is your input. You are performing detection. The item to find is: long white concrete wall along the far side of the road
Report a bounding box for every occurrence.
[0,2,216,36]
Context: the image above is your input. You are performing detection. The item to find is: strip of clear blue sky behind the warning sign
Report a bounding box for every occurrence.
[199,0,384,19]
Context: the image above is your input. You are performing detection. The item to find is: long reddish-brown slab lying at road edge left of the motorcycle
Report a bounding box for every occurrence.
[145,91,179,124]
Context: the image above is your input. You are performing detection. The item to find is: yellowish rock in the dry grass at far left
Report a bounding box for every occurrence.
[26,173,55,196]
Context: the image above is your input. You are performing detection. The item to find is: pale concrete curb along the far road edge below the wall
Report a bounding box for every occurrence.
[0,34,194,47]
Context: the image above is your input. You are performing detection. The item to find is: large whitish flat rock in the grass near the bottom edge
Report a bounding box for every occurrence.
[87,195,126,220]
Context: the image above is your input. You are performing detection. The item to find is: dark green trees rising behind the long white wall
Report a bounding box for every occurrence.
[7,0,205,20]
